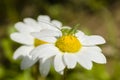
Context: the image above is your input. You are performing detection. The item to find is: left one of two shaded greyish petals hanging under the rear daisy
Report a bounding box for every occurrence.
[21,56,38,69]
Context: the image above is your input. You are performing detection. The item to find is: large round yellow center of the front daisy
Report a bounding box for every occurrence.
[55,35,82,53]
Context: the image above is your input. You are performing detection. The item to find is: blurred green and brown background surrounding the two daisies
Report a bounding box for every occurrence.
[0,0,120,80]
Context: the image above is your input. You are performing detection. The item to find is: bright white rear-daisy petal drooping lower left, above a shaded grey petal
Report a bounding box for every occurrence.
[13,46,34,59]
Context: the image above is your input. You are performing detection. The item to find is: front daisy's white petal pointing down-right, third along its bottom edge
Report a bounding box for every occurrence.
[77,55,92,70]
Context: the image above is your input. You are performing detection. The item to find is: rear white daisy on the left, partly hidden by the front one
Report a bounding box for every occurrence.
[10,15,61,76]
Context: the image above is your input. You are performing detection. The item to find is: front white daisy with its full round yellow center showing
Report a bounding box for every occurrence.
[30,28,106,73]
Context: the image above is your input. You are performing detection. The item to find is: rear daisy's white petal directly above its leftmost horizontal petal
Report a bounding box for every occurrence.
[15,22,34,33]
